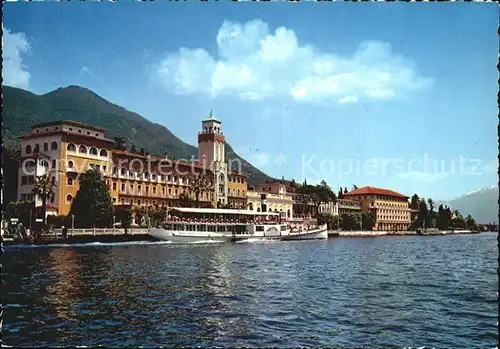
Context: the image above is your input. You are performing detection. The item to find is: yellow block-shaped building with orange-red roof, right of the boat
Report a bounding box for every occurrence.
[342,186,411,231]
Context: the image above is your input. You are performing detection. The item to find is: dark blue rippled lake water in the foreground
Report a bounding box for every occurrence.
[1,233,498,348]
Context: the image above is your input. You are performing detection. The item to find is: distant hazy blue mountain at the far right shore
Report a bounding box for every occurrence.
[440,185,499,223]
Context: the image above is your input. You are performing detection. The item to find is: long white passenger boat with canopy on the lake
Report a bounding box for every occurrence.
[149,207,328,243]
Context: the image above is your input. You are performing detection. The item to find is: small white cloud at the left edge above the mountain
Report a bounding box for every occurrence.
[2,26,31,89]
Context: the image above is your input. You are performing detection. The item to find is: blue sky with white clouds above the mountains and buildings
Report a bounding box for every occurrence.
[3,2,498,200]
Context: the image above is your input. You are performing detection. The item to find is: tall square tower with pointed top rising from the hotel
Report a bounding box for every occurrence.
[198,111,228,204]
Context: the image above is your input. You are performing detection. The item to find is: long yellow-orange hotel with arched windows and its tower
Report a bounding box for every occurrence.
[18,113,247,215]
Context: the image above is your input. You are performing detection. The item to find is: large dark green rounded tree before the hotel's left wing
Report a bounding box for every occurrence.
[69,168,113,228]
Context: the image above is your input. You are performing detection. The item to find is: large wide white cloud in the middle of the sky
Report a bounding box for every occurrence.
[153,20,432,103]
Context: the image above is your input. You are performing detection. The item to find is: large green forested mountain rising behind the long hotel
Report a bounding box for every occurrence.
[3,86,270,184]
